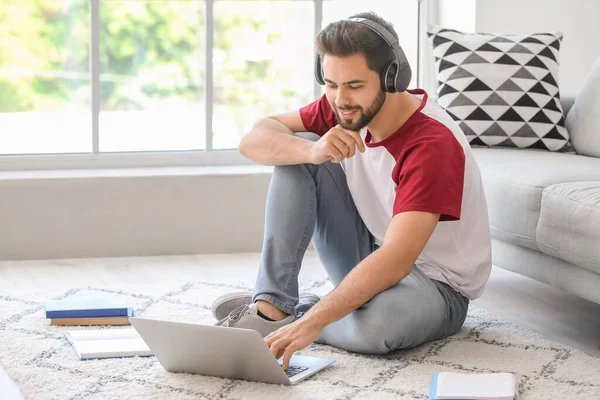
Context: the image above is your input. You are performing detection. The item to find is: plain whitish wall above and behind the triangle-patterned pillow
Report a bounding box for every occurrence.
[437,0,600,97]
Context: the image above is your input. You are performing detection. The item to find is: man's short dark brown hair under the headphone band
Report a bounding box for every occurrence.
[317,12,398,73]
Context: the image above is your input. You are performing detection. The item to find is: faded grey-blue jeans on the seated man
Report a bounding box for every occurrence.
[254,134,469,354]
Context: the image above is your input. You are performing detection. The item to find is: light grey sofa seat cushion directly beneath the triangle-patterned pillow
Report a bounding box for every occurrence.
[473,148,600,250]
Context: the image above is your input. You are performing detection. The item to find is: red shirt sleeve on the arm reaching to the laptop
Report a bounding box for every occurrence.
[393,127,465,221]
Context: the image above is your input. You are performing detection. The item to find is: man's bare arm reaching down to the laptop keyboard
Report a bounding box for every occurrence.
[265,211,440,368]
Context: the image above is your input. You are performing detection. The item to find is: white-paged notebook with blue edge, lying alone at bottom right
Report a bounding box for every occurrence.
[429,372,519,400]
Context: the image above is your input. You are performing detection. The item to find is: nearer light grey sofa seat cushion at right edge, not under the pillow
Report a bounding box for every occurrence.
[536,181,600,273]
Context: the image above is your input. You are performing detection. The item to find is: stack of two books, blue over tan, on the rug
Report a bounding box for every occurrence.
[44,298,133,325]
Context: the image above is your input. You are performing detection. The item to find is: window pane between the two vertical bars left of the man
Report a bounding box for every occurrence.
[99,0,206,152]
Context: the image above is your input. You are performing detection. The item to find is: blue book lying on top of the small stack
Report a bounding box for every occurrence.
[44,298,133,318]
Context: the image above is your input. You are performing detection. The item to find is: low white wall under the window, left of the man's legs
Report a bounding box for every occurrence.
[0,167,271,260]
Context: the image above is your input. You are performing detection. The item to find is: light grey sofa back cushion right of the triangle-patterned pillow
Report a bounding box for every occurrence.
[566,58,600,157]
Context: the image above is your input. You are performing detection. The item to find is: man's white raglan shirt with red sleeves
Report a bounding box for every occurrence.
[300,89,492,299]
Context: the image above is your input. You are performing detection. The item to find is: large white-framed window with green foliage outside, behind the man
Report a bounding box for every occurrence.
[0,0,418,165]
